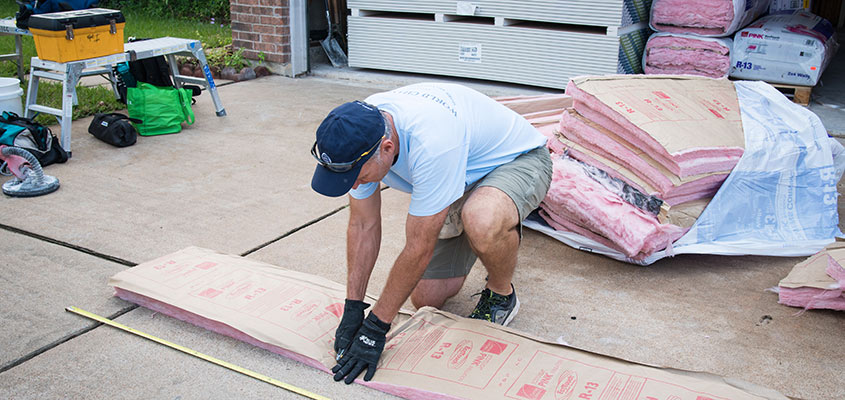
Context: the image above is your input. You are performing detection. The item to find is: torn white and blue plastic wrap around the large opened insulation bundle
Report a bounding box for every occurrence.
[524,82,845,265]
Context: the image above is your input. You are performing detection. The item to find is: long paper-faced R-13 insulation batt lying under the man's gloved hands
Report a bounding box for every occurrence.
[109,247,786,400]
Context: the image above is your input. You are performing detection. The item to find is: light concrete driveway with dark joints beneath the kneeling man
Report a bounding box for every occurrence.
[0,72,845,399]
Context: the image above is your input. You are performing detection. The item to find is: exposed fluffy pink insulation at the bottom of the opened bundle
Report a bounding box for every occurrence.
[543,157,685,259]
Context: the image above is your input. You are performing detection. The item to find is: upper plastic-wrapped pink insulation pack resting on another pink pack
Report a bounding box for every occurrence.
[650,0,771,37]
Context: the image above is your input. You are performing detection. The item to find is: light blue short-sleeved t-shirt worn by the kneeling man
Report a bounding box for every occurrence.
[349,83,546,216]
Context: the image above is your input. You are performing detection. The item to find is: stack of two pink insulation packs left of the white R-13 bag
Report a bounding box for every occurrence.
[643,0,771,78]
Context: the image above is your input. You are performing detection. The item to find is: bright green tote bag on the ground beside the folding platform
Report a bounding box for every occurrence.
[126,82,194,136]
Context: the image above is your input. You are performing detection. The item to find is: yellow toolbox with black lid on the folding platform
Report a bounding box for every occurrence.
[29,8,126,63]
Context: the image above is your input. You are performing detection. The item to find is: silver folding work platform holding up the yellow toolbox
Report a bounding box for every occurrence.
[24,37,226,154]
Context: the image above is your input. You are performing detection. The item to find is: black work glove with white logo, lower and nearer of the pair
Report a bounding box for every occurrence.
[332,311,390,385]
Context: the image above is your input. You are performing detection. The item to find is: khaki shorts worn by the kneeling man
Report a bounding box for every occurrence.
[423,146,552,279]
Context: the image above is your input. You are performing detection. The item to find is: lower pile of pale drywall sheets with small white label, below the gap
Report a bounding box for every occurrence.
[349,16,620,89]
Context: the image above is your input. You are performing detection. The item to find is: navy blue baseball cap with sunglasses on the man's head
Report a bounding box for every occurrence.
[311,101,384,197]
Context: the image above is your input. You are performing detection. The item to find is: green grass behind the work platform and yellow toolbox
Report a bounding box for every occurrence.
[0,1,232,125]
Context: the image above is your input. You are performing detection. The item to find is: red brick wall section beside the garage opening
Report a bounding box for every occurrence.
[229,0,291,69]
